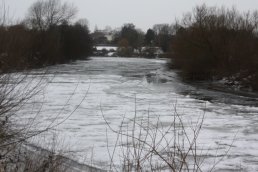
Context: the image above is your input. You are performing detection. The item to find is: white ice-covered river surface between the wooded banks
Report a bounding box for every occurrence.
[13,57,258,171]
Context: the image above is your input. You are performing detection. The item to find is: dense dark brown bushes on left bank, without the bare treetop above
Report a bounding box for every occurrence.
[0,21,92,72]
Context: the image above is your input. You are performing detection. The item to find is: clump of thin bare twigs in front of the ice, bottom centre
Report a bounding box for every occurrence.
[102,99,233,172]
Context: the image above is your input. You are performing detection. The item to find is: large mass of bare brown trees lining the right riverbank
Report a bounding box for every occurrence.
[170,5,258,90]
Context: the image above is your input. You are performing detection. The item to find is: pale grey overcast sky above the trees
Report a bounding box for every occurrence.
[4,0,258,31]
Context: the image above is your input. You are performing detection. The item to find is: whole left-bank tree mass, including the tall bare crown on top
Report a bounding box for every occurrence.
[0,0,92,71]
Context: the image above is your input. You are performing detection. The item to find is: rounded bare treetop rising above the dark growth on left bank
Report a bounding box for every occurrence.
[27,0,77,30]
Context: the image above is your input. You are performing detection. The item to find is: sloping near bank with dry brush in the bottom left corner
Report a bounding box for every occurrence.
[0,143,106,172]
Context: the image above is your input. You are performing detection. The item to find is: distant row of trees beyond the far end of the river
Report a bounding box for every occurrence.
[92,23,175,57]
